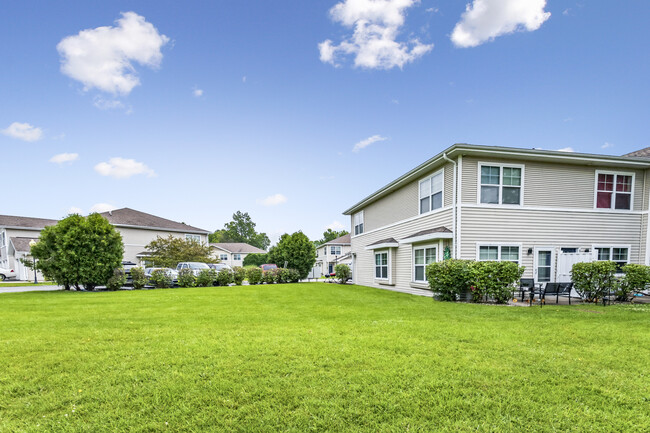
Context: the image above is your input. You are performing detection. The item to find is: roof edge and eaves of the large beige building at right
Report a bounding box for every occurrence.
[343,143,650,215]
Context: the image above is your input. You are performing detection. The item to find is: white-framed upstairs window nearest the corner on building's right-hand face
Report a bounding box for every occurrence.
[480,164,523,205]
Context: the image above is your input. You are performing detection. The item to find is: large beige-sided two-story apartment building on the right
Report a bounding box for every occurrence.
[344,144,650,289]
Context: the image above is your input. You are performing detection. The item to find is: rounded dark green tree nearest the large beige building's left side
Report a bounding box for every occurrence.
[268,231,316,279]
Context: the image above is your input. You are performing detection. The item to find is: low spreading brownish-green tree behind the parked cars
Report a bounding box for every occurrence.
[145,235,217,268]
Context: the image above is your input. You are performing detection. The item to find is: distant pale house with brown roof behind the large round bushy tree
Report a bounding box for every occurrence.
[0,208,209,280]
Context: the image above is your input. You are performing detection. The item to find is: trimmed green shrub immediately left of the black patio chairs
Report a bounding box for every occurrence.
[469,261,524,304]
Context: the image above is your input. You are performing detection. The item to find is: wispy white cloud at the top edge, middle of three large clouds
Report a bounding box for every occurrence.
[318,0,433,69]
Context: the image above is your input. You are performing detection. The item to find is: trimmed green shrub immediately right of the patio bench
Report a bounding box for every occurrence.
[571,261,617,302]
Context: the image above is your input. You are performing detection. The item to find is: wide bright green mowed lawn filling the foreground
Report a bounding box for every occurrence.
[0,283,650,432]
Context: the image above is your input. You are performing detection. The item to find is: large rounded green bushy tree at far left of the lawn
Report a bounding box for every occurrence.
[31,213,124,290]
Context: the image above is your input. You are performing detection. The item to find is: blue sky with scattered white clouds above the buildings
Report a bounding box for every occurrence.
[0,0,650,240]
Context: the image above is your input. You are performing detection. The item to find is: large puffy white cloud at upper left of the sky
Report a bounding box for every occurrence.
[56,12,169,95]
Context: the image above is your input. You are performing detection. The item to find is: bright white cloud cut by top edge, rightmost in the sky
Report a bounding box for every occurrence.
[451,0,551,48]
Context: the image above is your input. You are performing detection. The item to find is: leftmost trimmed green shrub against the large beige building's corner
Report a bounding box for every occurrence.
[426,259,474,302]
